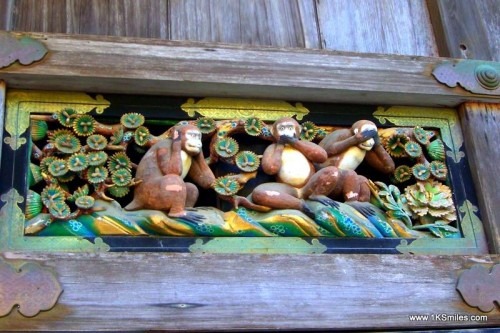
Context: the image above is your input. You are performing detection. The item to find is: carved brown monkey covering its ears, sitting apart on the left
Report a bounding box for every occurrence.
[125,125,215,217]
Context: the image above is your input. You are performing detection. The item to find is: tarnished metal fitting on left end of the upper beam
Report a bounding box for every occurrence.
[0,32,48,68]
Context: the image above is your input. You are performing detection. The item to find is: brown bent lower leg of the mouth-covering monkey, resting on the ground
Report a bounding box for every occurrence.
[252,183,304,210]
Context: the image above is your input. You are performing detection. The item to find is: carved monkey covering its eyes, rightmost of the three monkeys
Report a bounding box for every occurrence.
[318,120,395,201]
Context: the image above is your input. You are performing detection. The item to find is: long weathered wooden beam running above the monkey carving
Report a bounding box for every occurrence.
[0,34,500,106]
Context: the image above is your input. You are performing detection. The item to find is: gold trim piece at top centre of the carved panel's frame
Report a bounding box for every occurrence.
[181,97,309,121]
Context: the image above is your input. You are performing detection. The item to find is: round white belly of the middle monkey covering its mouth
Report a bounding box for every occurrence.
[278,147,312,187]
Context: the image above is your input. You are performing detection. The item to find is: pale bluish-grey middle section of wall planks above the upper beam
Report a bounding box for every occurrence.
[169,0,319,48]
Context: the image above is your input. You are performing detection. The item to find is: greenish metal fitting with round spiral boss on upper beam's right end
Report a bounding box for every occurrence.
[432,60,500,96]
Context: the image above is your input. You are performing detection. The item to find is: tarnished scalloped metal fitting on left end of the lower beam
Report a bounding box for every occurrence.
[0,257,63,317]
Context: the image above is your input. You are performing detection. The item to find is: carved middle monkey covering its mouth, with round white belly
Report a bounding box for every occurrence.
[241,118,336,216]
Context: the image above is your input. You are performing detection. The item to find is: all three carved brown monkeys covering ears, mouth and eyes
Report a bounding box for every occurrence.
[125,118,394,217]
